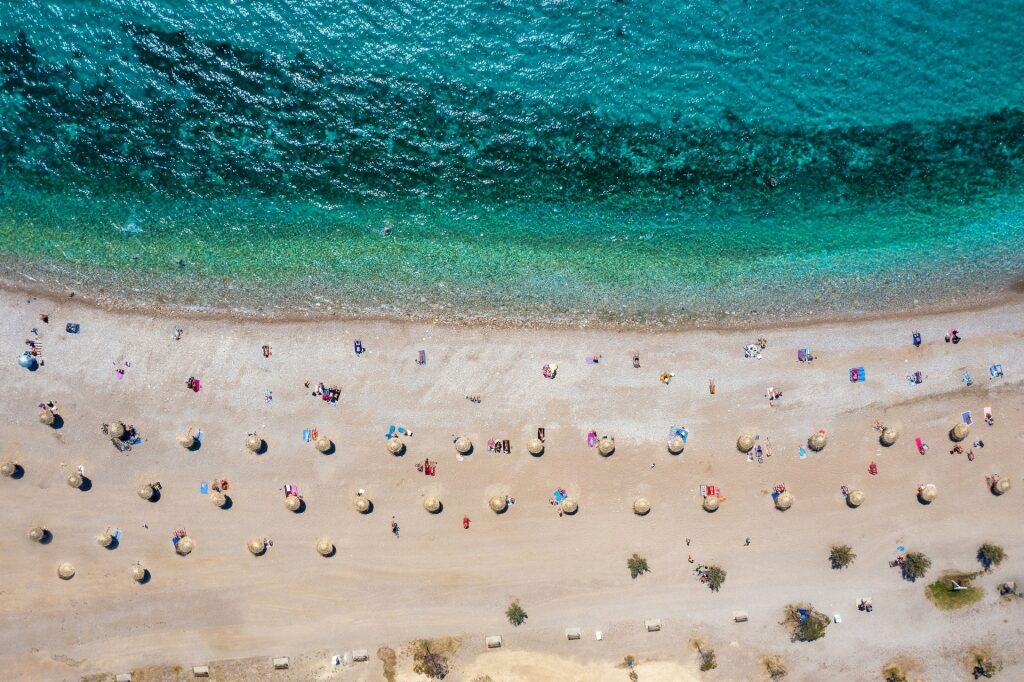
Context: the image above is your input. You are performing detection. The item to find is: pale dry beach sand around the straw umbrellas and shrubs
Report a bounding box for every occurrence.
[0,293,1024,682]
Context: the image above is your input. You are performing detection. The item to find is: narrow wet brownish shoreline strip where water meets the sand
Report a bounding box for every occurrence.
[0,275,1024,333]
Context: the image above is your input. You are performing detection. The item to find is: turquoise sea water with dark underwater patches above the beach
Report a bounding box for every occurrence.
[0,0,1024,324]
